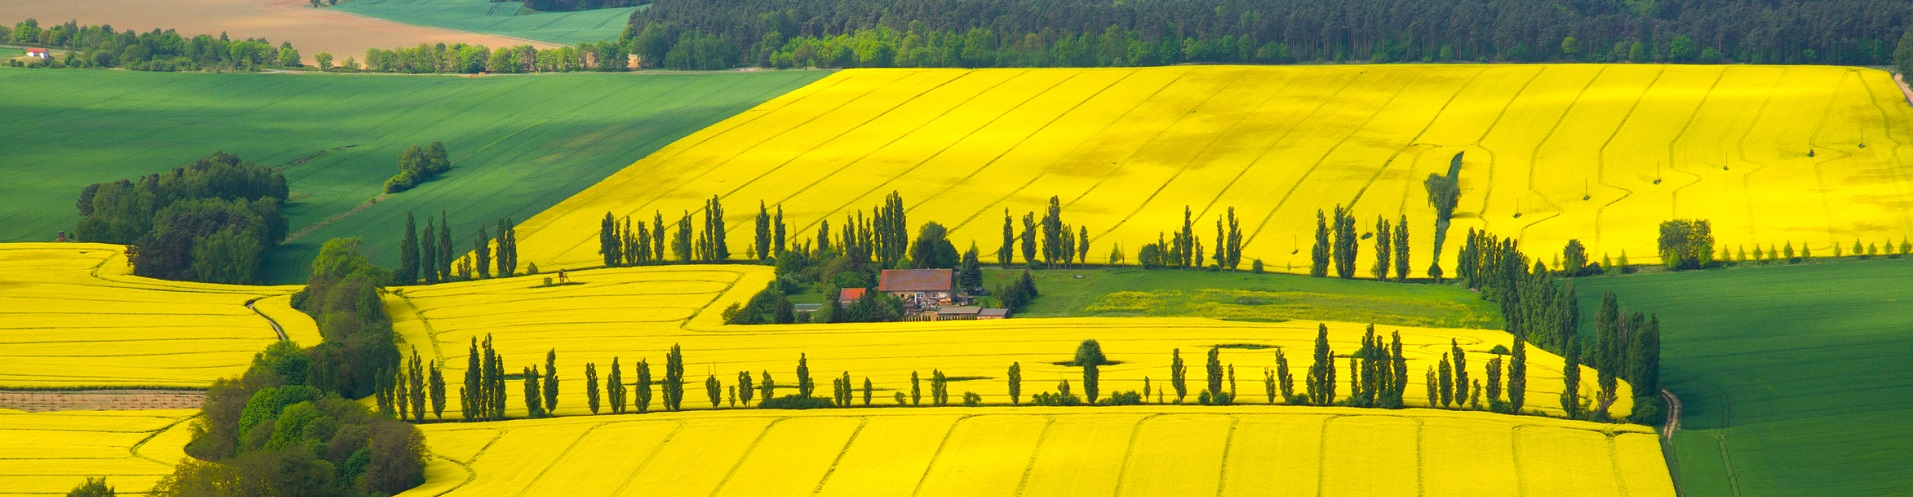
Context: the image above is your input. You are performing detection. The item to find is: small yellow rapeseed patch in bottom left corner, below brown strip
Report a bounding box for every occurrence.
[0,409,199,497]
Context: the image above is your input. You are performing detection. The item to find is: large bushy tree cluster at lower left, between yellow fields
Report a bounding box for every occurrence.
[153,239,427,495]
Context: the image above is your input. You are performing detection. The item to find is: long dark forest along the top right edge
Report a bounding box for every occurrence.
[615,0,1913,69]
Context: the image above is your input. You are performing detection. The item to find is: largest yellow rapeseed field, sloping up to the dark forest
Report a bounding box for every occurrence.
[518,65,1913,273]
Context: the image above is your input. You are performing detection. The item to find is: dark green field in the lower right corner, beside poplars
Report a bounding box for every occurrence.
[1574,260,1913,497]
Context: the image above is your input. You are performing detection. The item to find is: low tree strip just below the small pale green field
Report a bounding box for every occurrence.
[344,40,631,75]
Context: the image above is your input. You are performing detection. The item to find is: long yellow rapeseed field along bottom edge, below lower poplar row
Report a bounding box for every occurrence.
[402,405,1674,497]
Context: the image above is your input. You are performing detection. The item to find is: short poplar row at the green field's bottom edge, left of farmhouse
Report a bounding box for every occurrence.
[392,210,518,285]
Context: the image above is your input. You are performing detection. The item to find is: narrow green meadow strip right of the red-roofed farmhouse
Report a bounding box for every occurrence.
[983,268,1502,329]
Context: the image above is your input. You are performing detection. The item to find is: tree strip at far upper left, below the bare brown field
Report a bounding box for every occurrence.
[0,19,302,71]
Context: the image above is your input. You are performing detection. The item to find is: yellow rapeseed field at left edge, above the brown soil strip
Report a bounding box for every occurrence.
[0,243,319,388]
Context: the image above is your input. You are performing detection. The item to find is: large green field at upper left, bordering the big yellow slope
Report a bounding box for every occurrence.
[0,69,826,283]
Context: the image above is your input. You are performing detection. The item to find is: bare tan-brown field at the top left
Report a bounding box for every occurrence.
[0,0,553,63]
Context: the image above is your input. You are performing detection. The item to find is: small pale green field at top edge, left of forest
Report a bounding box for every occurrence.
[335,0,637,44]
